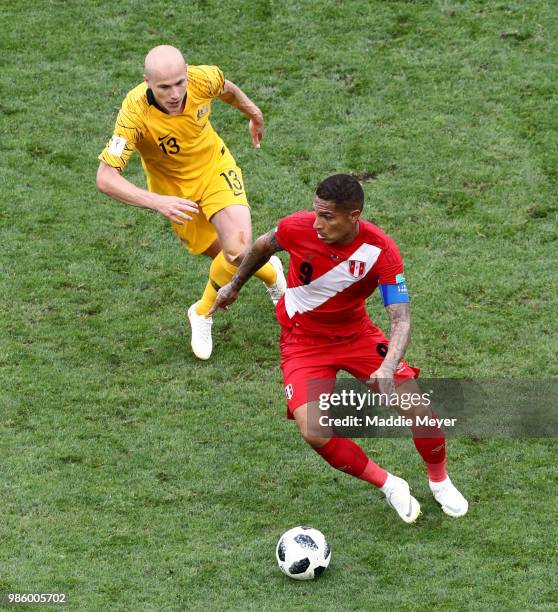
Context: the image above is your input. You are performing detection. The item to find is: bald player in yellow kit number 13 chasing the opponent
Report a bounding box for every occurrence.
[97,45,286,359]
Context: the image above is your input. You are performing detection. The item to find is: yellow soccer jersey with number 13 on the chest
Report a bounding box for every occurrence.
[99,66,229,189]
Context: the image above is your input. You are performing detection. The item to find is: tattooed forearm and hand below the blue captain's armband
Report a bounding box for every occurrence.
[370,303,411,394]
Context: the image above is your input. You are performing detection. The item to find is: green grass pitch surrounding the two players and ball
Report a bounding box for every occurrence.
[0,0,558,611]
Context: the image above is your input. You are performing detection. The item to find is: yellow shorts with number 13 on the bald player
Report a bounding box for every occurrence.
[148,147,248,255]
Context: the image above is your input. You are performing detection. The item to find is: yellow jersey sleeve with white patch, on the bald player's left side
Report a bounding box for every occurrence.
[99,96,145,172]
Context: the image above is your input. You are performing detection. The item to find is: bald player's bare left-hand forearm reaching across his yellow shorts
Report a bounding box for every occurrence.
[97,162,198,225]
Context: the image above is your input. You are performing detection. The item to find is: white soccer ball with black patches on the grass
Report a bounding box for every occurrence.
[275,527,331,580]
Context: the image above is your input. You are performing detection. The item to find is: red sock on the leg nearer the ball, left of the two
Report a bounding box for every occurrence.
[314,438,387,487]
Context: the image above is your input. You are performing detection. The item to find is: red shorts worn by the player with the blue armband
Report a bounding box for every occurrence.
[280,321,420,419]
